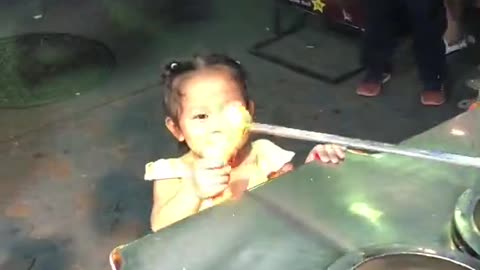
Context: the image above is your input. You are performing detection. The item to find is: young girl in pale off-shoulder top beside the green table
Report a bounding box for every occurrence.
[145,55,344,231]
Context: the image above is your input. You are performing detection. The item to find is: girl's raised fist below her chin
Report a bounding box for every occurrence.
[192,160,232,200]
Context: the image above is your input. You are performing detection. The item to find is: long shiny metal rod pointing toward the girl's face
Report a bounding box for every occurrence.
[251,123,480,168]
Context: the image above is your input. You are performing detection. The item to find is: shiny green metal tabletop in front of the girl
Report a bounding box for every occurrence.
[113,111,480,270]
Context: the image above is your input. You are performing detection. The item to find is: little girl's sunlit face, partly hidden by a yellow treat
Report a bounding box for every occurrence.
[166,68,253,157]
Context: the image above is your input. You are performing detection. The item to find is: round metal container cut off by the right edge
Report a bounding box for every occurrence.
[452,189,480,259]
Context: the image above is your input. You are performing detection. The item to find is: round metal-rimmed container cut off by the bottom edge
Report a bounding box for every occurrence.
[328,246,480,270]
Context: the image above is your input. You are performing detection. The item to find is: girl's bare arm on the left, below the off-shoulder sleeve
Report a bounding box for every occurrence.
[150,179,201,232]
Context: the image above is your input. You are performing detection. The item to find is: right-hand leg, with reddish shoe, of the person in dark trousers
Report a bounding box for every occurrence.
[405,0,447,105]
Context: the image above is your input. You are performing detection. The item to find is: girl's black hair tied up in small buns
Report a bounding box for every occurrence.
[162,54,249,123]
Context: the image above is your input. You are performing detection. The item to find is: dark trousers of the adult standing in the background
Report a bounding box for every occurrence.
[362,0,447,90]
